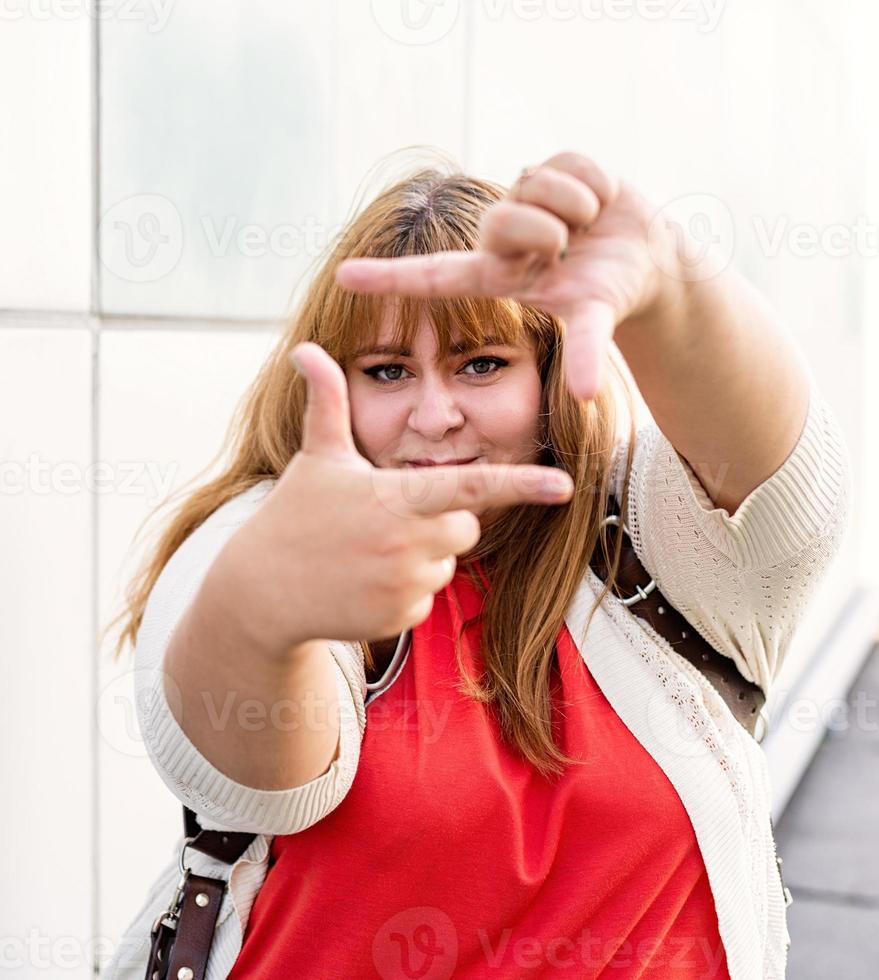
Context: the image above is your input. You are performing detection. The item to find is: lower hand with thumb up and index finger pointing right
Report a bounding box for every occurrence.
[211,342,573,656]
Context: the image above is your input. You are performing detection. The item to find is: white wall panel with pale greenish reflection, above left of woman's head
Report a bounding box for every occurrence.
[100,0,336,318]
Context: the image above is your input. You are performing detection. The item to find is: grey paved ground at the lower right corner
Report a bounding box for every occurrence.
[776,647,879,980]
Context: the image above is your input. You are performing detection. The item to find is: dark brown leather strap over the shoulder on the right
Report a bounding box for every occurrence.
[591,496,766,735]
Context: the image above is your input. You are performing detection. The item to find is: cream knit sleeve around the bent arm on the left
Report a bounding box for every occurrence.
[135,481,366,834]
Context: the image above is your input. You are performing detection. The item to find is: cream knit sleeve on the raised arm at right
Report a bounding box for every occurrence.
[616,379,851,692]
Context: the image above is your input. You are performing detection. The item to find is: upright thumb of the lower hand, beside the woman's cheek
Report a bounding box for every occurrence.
[289,341,360,459]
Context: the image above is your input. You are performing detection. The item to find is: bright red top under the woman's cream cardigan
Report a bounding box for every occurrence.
[229,567,729,980]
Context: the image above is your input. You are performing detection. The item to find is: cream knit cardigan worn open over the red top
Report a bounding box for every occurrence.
[103,379,851,980]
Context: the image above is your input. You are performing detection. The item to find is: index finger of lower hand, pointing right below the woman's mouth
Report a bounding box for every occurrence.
[383,463,574,516]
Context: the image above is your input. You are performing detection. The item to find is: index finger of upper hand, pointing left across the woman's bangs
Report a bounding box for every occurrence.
[336,250,490,296]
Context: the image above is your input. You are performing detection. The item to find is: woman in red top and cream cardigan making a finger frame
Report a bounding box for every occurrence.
[107,153,850,980]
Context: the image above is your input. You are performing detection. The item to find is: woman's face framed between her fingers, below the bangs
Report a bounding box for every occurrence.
[346,317,541,478]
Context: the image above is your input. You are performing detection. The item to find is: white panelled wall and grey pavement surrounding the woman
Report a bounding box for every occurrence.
[0,0,879,980]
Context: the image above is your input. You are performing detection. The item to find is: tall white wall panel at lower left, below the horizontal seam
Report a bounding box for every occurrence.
[0,325,98,980]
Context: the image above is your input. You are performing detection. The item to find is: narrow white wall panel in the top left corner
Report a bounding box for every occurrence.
[0,21,93,311]
